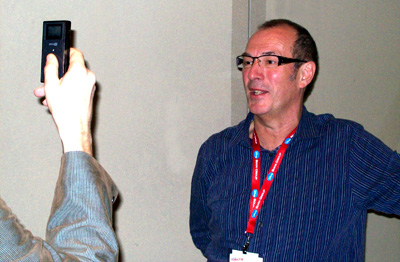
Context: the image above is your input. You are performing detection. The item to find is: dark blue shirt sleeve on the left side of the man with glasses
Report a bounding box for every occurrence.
[189,144,211,254]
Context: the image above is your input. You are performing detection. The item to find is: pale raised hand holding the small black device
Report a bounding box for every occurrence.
[34,48,96,155]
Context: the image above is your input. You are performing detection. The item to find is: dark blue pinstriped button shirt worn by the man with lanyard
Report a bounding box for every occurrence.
[190,108,400,262]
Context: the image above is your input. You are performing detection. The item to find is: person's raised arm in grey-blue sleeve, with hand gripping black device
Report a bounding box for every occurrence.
[0,49,118,262]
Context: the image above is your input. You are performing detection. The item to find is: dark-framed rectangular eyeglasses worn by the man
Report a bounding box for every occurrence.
[236,55,307,71]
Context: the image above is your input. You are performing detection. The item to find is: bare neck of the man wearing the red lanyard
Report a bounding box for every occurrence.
[249,108,302,150]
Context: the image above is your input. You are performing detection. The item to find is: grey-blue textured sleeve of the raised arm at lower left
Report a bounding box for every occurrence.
[0,152,118,262]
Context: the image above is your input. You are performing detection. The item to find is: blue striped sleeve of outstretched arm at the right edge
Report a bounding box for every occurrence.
[349,124,400,215]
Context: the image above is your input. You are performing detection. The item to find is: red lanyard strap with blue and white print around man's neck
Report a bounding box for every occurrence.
[246,127,297,234]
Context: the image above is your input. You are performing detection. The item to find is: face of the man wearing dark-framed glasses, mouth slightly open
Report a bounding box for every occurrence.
[242,26,302,119]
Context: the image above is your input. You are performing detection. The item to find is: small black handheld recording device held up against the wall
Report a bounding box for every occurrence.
[40,20,71,83]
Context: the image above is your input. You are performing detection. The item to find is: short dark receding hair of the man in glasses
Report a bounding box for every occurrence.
[258,19,319,98]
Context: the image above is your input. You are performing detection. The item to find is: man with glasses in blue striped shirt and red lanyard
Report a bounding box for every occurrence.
[190,19,400,262]
